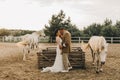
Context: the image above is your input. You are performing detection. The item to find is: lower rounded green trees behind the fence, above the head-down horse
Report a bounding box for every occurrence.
[83,19,120,37]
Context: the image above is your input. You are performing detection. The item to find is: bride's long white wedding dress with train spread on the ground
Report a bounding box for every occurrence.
[41,37,64,72]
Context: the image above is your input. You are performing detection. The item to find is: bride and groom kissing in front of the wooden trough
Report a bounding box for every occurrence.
[41,28,72,72]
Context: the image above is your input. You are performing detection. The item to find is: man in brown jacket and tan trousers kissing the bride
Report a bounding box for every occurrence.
[60,28,72,72]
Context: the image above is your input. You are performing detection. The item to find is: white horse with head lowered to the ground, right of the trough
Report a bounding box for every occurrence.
[82,36,108,73]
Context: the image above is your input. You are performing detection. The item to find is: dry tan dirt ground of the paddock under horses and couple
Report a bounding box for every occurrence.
[0,43,120,80]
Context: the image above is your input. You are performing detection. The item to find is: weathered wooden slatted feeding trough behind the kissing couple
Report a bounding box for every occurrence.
[37,47,85,69]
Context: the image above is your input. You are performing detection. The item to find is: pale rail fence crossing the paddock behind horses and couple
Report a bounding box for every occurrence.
[0,36,120,43]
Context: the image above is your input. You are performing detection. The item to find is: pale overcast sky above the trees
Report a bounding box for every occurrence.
[0,0,120,30]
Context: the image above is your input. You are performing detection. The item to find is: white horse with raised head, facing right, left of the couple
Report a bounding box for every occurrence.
[17,31,45,60]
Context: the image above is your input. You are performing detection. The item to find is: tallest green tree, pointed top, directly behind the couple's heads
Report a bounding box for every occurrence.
[44,10,81,37]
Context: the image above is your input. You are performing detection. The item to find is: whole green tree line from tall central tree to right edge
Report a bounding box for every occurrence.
[44,10,120,37]
